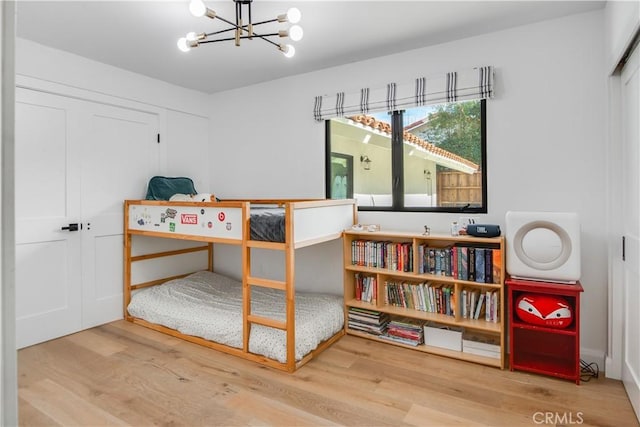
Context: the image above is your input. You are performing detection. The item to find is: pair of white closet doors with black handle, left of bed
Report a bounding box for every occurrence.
[16,89,160,348]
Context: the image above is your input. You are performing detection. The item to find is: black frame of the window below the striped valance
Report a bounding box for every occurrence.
[325,99,488,214]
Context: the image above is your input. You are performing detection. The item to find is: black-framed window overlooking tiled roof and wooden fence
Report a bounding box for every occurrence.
[326,99,487,213]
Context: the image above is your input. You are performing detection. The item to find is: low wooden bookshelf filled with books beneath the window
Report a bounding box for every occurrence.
[343,230,506,369]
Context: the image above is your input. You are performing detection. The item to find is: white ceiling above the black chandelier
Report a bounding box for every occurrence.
[17,0,605,93]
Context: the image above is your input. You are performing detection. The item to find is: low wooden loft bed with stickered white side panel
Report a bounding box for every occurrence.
[124,200,357,372]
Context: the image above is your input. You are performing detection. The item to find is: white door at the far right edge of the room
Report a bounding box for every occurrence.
[622,41,640,419]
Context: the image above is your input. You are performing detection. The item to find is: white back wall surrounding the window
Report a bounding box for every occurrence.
[210,11,607,366]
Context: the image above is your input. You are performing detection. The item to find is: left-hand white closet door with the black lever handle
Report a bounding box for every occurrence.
[15,89,81,348]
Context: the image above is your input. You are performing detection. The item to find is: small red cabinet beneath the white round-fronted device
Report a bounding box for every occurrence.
[505,278,583,384]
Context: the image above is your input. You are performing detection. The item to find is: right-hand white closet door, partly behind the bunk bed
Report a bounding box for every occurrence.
[81,105,160,328]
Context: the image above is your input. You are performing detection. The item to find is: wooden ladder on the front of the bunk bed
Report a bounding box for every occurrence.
[242,203,296,372]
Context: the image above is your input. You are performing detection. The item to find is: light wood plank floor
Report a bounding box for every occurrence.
[18,321,638,427]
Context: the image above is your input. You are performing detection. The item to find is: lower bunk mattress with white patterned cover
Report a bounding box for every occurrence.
[128,271,344,363]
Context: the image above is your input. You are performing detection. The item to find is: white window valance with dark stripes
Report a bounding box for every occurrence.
[313,66,493,122]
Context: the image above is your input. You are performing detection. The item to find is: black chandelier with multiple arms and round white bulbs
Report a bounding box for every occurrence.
[178,0,303,58]
